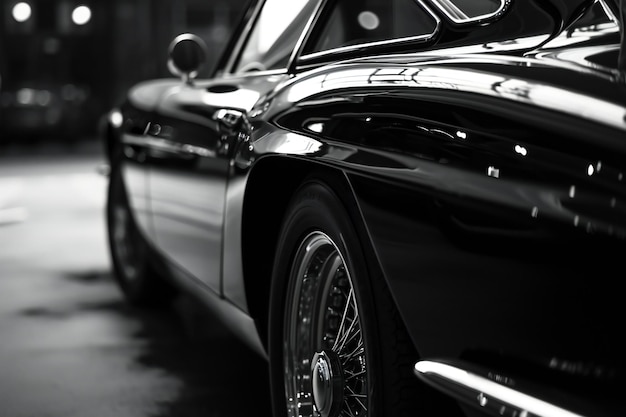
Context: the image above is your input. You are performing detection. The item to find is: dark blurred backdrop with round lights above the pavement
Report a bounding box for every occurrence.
[0,0,246,145]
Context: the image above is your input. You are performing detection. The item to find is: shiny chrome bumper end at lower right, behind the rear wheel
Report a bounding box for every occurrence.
[414,360,582,417]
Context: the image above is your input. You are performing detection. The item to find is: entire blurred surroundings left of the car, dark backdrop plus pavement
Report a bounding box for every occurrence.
[0,0,270,417]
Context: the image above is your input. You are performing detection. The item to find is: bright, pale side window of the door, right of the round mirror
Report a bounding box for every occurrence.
[235,0,318,73]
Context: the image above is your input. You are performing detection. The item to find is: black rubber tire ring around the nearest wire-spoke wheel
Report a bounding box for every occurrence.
[269,180,380,416]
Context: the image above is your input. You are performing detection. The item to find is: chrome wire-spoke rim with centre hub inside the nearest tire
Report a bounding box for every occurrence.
[283,231,368,417]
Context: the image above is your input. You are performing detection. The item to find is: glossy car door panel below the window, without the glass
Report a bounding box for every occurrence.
[148,77,279,296]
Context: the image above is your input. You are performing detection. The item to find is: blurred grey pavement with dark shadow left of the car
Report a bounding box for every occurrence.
[0,140,270,417]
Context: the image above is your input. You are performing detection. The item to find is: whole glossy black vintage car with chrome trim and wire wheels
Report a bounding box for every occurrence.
[106,0,626,417]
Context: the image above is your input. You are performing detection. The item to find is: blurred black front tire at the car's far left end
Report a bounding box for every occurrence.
[106,165,175,307]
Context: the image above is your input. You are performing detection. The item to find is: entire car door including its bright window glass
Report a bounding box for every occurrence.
[147,0,318,294]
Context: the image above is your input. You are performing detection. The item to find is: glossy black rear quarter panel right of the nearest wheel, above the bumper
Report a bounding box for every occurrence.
[273,59,626,412]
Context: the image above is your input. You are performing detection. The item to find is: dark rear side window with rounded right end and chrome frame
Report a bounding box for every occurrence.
[304,0,438,54]
